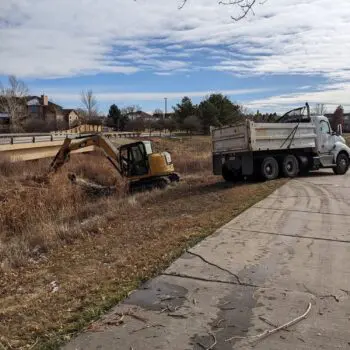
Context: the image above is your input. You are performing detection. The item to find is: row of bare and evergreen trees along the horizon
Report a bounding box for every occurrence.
[0,76,344,134]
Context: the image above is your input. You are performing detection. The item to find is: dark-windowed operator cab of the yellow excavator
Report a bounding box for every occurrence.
[120,142,149,176]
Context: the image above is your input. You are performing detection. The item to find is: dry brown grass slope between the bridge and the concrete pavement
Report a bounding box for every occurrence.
[0,138,284,349]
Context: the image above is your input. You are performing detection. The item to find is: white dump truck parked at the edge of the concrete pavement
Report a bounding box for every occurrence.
[211,104,350,182]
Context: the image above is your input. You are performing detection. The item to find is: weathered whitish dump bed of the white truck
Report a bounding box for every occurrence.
[212,120,316,154]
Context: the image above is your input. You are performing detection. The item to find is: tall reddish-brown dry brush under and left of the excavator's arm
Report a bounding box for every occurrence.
[0,155,126,267]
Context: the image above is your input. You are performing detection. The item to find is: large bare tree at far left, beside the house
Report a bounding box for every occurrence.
[0,75,28,131]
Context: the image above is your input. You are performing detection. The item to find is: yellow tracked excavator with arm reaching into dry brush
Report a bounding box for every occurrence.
[50,134,180,191]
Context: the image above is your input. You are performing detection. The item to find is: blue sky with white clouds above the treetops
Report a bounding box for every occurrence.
[0,0,350,112]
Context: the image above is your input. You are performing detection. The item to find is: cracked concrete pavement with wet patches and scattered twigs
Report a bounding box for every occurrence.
[64,173,350,350]
